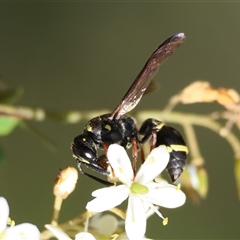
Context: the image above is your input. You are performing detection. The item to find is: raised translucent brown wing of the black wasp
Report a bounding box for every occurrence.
[111,33,185,119]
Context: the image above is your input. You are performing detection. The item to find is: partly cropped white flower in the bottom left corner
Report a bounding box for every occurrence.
[0,197,40,240]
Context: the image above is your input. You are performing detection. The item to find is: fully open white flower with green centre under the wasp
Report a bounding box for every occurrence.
[86,144,186,240]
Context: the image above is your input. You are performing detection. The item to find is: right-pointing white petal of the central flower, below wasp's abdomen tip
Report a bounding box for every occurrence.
[143,183,186,208]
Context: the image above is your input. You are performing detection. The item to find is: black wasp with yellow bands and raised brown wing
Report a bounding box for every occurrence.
[71,33,187,185]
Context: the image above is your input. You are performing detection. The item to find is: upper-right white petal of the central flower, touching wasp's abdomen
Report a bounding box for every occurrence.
[135,145,169,184]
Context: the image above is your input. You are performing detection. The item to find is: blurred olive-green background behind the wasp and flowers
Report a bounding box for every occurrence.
[0,2,240,239]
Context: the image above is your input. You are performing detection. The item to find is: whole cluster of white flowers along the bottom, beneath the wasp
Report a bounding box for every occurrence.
[0,144,186,240]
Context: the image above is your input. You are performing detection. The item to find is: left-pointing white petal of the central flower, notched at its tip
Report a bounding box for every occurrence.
[86,185,130,212]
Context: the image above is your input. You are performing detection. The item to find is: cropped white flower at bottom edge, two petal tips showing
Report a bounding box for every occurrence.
[45,224,96,240]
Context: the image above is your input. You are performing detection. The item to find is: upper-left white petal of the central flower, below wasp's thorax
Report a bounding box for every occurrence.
[107,144,133,185]
